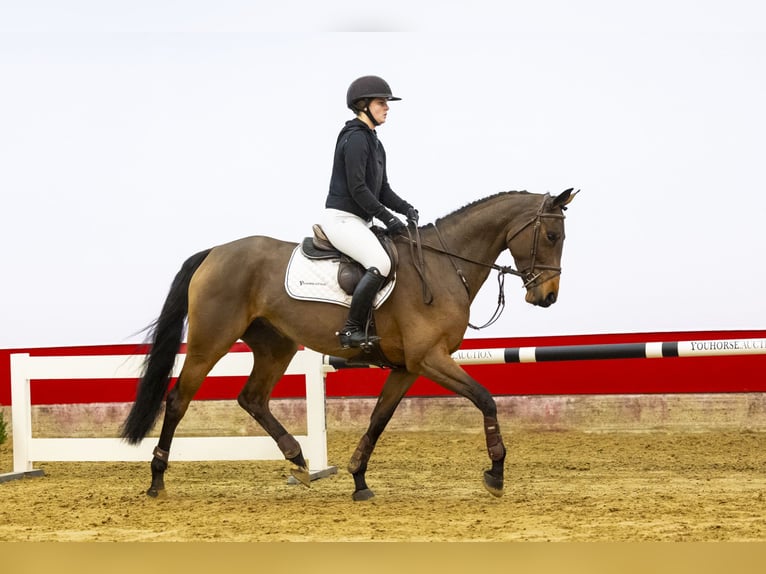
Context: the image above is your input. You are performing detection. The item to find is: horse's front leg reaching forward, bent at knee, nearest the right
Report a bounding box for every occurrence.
[421,350,506,496]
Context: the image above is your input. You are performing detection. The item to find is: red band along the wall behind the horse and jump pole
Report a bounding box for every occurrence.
[0,330,766,405]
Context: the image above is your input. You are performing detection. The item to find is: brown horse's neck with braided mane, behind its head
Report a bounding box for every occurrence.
[435,194,536,300]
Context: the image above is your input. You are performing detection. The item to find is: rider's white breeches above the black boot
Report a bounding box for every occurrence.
[322,209,391,277]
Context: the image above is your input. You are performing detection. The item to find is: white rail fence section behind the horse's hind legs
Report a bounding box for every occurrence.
[0,349,337,481]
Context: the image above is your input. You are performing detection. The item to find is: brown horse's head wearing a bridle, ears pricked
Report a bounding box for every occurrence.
[505,188,579,307]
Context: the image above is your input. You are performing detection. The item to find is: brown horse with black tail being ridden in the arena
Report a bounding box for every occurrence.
[120,189,579,501]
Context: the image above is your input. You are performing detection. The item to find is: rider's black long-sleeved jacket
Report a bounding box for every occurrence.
[325,118,411,221]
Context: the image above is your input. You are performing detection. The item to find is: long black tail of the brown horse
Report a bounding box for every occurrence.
[120,249,210,444]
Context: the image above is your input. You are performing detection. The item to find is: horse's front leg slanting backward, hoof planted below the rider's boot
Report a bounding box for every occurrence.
[348,369,417,501]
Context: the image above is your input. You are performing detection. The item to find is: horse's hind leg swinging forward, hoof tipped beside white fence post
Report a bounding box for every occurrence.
[237,321,311,486]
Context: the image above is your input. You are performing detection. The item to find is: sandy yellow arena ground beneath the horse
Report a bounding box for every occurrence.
[0,429,766,542]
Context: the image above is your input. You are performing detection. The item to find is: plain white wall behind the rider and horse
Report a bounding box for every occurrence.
[0,0,766,348]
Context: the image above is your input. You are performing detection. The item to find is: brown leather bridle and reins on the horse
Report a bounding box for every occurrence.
[407,193,565,330]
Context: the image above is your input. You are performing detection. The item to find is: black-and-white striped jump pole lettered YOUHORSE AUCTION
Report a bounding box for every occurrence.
[323,339,766,372]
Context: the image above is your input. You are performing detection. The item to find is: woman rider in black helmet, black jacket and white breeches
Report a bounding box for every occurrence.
[322,76,418,348]
